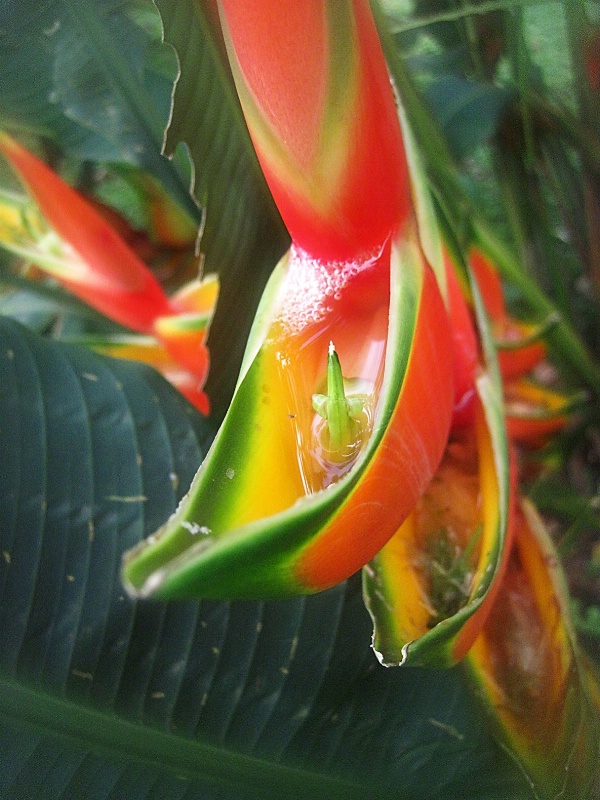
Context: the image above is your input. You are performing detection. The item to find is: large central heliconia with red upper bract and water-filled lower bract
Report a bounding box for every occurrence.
[123,0,453,598]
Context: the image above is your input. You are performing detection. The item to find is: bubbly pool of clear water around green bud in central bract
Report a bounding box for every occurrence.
[265,245,390,494]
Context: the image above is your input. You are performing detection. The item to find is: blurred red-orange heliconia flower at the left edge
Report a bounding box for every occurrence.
[0,133,219,412]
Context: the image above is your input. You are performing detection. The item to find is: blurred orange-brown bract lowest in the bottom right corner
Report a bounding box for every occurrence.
[465,500,600,800]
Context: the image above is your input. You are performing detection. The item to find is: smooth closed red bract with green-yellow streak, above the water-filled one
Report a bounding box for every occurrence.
[221,0,410,260]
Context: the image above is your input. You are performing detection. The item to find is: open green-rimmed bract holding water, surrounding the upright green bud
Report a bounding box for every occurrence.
[123,226,452,598]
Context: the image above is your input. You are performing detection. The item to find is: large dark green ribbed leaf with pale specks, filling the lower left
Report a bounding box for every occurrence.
[0,319,531,800]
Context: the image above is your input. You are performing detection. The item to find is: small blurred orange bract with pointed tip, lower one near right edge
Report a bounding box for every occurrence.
[504,378,587,448]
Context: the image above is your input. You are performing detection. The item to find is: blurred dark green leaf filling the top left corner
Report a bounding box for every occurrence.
[0,0,200,221]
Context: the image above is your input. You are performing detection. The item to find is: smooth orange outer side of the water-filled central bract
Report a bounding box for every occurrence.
[295,253,452,587]
